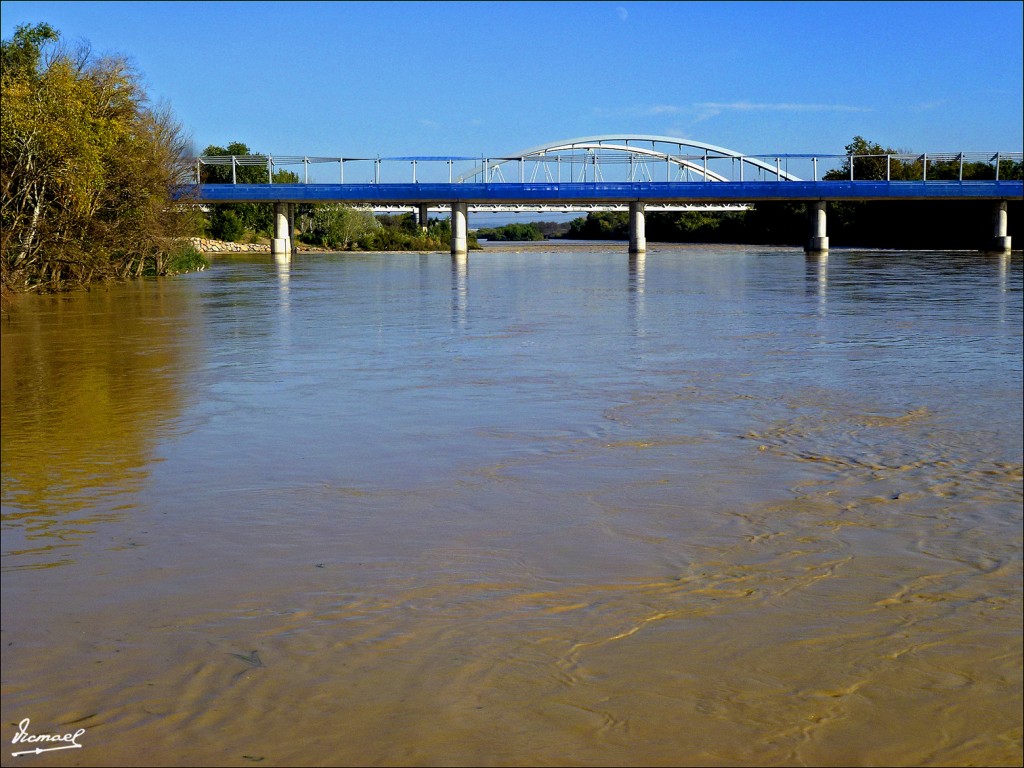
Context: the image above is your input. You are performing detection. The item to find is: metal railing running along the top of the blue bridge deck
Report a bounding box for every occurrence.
[195,151,1024,184]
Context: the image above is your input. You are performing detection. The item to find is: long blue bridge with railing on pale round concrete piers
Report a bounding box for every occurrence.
[182,135,1024,258]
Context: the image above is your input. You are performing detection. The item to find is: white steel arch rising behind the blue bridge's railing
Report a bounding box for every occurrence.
[458,134,801,181]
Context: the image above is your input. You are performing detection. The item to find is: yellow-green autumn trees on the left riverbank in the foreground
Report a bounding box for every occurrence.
[0,24,197,292]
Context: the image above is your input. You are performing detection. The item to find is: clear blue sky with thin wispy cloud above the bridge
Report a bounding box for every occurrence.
[0,0,1024,156]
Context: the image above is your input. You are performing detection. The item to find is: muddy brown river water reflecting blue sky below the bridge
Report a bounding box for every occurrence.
[2,245,1024,766]
